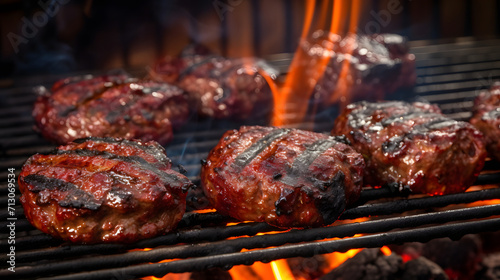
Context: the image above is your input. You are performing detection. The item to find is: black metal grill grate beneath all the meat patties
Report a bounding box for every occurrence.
[0,37,500,279]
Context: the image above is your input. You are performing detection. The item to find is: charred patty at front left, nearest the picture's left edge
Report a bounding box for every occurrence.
[19,138,192,243]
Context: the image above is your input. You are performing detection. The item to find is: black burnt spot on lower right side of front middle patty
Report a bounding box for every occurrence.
[316,171,347,224]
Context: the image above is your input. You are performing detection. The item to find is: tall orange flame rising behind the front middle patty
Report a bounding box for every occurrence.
[271,0,361,126]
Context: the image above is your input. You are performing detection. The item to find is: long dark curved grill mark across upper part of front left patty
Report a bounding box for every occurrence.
[57,149,184,185]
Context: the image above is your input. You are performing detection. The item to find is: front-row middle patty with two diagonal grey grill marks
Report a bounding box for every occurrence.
[201,126,364,227]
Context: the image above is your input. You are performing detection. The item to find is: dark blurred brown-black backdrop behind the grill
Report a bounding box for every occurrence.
[0,0,500,78]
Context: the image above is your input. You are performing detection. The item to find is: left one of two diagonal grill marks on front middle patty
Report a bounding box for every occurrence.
[233,128,292,170]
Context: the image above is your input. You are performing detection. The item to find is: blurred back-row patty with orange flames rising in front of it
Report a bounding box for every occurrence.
[301,30,416,109]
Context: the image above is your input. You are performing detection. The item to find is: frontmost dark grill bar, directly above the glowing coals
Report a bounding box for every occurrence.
[22,210,500,279]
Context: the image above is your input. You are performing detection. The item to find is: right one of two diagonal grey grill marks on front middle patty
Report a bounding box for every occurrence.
[280,138,337,186]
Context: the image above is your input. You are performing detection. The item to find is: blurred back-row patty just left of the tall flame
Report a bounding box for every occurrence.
[151,46,273,120]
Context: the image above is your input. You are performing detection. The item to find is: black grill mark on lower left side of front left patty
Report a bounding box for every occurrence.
[23,174,102,210]
